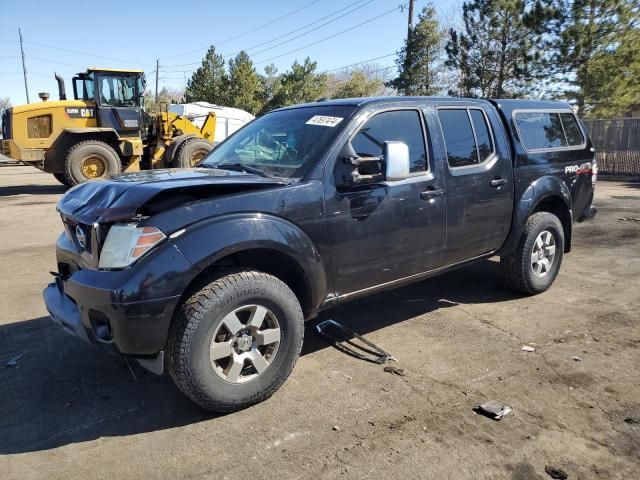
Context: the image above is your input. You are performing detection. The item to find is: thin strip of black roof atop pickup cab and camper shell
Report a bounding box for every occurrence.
[278,96,571,111]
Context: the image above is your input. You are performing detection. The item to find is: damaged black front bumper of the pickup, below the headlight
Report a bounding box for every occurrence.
[43,235,192,374]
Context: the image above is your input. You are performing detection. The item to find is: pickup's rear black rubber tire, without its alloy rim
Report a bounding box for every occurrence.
[500,212,564,295]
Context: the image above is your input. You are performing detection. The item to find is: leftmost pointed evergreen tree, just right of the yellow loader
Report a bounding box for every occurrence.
[185,46,229,105]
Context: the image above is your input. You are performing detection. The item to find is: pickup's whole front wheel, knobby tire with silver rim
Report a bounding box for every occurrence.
[167,271,304,412]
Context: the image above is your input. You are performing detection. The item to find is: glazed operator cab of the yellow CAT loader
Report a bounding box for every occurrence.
[73,69,146,137]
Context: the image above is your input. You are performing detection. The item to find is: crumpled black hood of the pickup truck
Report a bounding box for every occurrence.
[57,168,287,225]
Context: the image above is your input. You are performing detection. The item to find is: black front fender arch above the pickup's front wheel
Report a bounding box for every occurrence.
[173,213,327,316]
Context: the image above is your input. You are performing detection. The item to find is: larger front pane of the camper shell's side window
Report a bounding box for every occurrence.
[515,112,568,150]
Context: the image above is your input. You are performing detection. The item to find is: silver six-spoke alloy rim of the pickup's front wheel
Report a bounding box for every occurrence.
[209,305,281,384]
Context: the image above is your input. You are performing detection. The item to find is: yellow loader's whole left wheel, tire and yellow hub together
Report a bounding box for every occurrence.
[64,140,122,185]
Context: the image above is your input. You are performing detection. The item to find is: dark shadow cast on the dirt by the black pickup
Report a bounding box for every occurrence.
[0,261,517,455]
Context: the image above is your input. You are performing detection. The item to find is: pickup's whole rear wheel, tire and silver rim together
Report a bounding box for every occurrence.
[500,212,564,295]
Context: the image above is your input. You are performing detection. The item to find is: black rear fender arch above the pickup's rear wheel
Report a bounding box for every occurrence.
[496,175,573,255]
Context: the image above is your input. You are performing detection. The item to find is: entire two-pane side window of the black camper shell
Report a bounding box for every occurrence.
[514,111,585,151]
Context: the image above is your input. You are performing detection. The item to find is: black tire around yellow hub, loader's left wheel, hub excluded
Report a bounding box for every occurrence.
[64,140,122,186]
